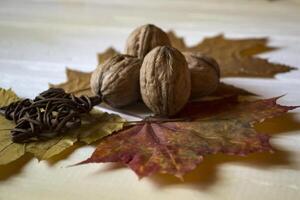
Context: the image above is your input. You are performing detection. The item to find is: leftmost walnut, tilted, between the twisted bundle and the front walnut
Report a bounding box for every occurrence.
[91,55,142,108]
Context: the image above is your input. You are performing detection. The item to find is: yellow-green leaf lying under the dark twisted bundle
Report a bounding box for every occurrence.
[0,88,124,165]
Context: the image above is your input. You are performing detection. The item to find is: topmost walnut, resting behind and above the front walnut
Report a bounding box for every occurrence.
[125,24,171,59]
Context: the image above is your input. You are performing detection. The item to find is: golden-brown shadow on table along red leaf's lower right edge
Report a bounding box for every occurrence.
[151,150,293,190]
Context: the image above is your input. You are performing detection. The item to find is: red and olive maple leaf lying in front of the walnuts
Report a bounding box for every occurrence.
[79,97,296,178]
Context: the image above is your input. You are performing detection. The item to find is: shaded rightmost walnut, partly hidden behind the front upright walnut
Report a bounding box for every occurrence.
[183,52,220,98]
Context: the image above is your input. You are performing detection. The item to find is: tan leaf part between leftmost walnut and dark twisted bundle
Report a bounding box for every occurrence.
[49,68,93,96]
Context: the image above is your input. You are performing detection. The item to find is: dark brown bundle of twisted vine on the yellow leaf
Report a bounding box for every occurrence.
[1,88,101,143]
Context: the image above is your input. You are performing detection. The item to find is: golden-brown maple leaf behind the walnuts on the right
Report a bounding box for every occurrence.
[168,31,295,77]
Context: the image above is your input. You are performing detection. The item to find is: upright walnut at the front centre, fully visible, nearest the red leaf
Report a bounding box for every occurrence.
[140,46,191,116]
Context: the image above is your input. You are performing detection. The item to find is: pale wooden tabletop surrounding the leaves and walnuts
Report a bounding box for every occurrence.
[0,0,300,200]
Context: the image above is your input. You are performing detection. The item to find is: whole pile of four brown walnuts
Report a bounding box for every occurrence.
[91,24,220,117]
